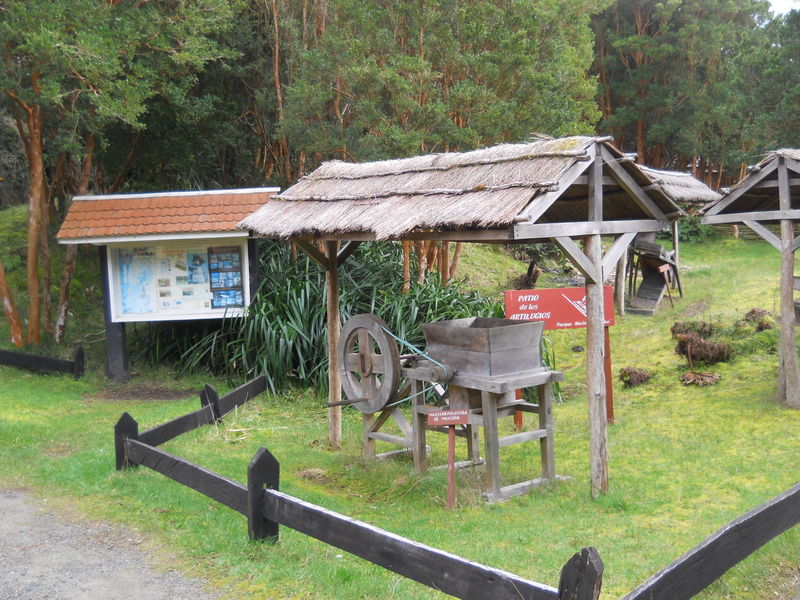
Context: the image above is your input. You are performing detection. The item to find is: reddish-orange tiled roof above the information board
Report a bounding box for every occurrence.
[58,188,278,241]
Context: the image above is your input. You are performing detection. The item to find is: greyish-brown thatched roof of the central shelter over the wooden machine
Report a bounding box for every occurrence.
[239,136,712,240]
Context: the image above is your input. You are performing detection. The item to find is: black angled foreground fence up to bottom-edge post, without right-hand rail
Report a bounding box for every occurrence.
[114,382,602,600]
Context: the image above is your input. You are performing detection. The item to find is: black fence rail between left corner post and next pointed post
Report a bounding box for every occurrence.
[125,438,247,516]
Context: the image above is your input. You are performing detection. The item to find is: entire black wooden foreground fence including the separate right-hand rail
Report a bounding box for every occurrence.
[115,378,800,600]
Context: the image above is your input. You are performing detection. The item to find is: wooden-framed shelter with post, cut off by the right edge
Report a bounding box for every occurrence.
[702,149,800,409]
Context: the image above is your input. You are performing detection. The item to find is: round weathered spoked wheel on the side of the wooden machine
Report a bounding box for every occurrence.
[339,314,400,414]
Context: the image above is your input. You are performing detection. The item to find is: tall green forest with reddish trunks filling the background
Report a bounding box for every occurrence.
[0,0,800,345]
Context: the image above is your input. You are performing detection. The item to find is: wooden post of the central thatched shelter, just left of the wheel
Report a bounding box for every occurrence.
[325,242,342,449]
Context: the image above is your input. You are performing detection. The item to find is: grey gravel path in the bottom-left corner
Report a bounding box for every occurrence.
[0,489,217,600]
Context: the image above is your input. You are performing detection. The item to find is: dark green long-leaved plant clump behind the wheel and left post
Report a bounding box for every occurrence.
[136,242,503,391]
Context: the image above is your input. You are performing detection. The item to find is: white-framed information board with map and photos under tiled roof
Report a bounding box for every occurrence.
[108,240,250,322]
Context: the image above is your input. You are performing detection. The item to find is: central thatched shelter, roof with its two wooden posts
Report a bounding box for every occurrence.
[239,136,708,495]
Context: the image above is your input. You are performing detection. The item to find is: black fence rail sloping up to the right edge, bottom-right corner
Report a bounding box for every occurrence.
[623,483,800,600]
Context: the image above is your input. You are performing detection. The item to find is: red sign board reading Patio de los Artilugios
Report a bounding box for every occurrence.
[505,285,614,329]
